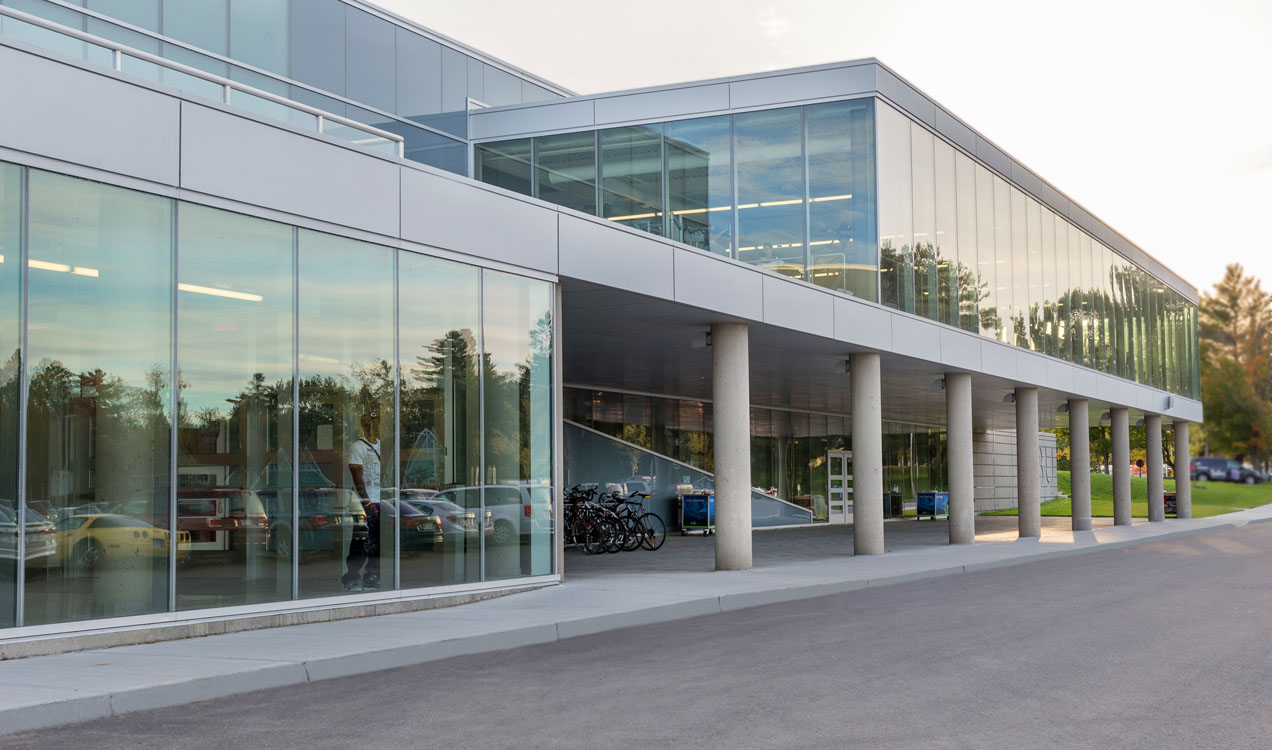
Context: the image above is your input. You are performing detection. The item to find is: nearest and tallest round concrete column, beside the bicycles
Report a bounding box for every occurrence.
[711,323,750,571]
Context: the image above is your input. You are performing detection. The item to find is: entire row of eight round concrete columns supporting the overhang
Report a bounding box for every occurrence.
[711,323,1192,571]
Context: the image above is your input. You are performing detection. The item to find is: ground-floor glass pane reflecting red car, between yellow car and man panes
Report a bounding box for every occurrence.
[177,203,292,609]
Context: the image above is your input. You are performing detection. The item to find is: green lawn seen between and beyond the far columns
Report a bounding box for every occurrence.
[985,472,1272,519]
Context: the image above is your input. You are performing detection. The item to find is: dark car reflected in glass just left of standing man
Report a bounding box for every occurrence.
[257,487,366,559]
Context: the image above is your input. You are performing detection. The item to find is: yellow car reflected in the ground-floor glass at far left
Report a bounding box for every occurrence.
[57,514,190,571]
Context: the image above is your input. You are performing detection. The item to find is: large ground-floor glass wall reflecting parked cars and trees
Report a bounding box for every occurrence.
[0,163,556,627]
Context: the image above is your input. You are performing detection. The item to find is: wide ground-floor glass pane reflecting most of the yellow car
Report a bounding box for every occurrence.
[25,170,173,624]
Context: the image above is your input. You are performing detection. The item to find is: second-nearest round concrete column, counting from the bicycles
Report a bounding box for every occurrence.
[848,352,883,554]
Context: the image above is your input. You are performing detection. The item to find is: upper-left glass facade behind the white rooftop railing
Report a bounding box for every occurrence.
[0,0,561,174]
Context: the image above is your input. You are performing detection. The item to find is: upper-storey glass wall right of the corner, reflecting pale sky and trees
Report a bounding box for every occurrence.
[878,106,1199,398]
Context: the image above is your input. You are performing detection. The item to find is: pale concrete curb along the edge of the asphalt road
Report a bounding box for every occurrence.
[0,517,1272,736]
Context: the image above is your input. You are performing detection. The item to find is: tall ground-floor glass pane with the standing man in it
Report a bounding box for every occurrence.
[298,230,397,596]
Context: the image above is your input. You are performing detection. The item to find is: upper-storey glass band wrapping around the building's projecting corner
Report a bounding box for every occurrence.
[473,99,1201,399]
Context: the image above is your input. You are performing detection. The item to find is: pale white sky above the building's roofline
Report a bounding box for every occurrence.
[374,0,1272,298]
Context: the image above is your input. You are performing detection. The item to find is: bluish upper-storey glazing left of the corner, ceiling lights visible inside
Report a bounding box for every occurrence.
[473,99,879,301]
